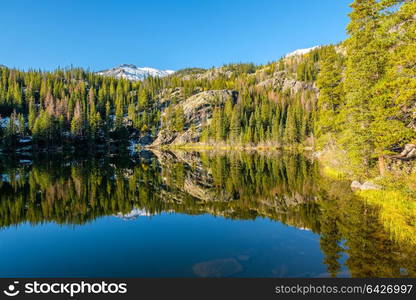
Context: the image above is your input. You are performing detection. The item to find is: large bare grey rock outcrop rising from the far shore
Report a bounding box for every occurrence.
[151,90,238,147]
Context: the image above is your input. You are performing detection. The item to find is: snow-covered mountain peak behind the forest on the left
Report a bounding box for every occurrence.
[97,64,175,80]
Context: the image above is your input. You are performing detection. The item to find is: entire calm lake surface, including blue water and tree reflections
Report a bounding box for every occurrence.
[0,152,416,277]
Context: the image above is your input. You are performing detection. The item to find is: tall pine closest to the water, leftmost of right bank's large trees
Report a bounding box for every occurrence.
[343,0,384,170]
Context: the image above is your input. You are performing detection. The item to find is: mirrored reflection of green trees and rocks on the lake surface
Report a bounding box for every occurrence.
[0,151,416,277]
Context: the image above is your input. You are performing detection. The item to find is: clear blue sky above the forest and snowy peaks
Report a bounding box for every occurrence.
[0,0,352,71]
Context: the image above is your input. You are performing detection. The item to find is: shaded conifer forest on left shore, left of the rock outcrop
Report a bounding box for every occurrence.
[0,67,165,145]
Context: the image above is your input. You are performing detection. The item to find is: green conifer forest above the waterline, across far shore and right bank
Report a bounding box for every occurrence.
[0,0,416,176]
